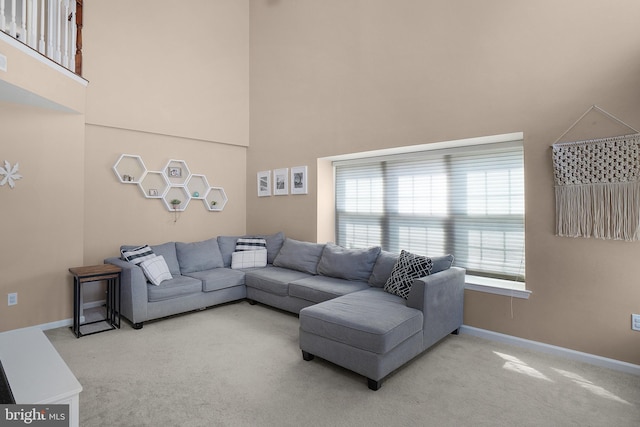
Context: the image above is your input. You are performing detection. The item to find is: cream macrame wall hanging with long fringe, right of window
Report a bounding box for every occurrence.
[552,105,640,241]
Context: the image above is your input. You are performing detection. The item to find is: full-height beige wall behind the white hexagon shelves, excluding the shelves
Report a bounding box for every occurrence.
[83,0,249,263]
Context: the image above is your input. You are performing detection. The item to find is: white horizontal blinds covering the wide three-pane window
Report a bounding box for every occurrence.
[334,141,524,280]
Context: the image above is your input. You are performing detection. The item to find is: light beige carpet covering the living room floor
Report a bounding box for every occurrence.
[46,302,640,427]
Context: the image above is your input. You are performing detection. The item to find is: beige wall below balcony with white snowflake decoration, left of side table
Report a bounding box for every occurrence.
[0,103,84,331]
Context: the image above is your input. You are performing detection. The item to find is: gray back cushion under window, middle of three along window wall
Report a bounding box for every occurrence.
[318,243,380,282]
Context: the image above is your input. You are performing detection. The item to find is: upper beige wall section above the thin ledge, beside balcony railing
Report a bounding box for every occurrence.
[83,0,249,146]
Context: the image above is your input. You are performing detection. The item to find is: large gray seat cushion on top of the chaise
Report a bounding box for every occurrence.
[300,288,423,354]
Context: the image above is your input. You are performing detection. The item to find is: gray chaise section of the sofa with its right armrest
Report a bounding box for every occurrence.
[300,256,465,390]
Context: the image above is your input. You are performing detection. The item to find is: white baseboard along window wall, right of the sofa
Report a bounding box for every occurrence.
[460,325,640,376]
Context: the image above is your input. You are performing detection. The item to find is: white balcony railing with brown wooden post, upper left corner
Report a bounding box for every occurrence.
[0,0,83,75]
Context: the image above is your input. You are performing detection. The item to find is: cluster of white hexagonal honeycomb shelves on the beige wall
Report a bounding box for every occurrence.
[113,154,228,213]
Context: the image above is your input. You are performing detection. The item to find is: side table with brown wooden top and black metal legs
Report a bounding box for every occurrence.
[69,264,122,338]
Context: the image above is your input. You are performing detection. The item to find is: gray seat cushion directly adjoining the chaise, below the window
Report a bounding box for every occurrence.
[289,276,369,303]
